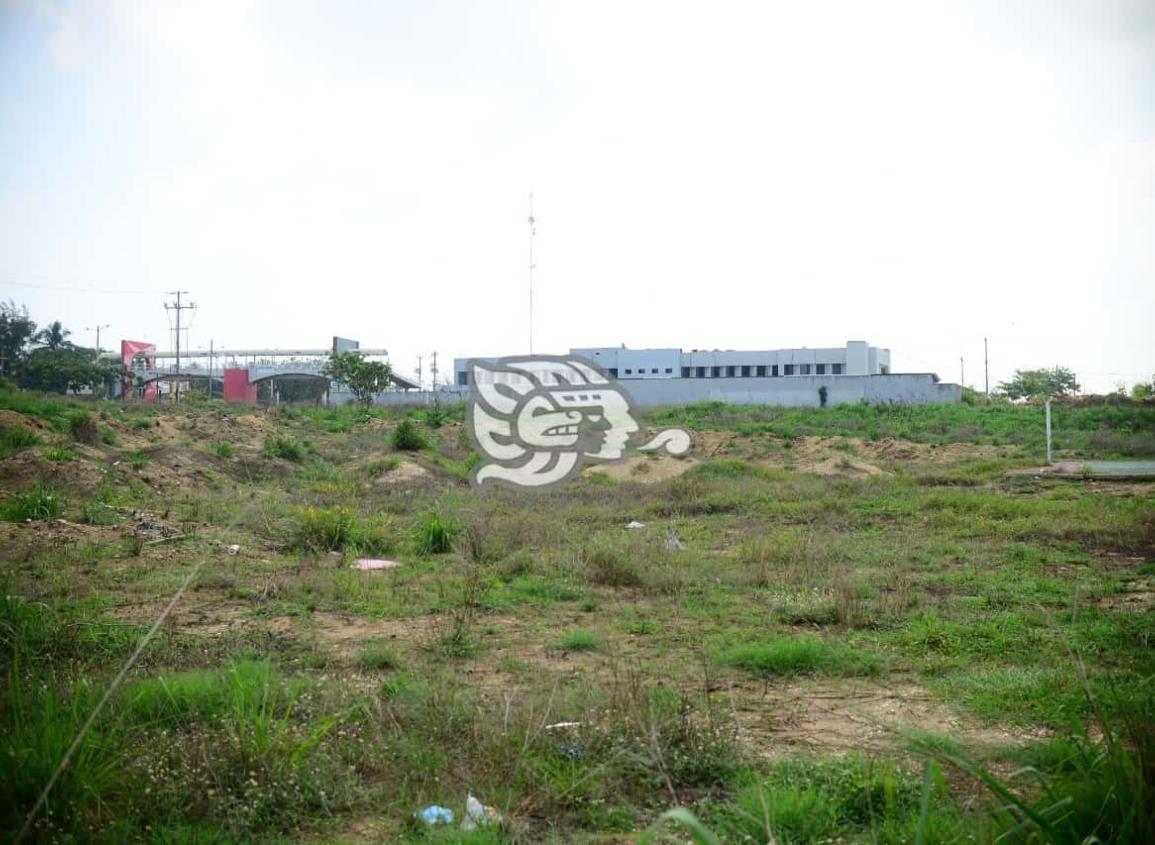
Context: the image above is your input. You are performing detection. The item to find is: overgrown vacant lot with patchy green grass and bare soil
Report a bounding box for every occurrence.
[0,391,1155,843]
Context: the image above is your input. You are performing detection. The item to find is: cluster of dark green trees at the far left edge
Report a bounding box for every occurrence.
[0,300,124,394]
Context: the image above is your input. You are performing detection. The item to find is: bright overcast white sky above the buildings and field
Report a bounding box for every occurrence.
[0,0,1155,391]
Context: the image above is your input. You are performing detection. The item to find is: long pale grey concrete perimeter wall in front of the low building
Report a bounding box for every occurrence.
[364,373,962,407]
